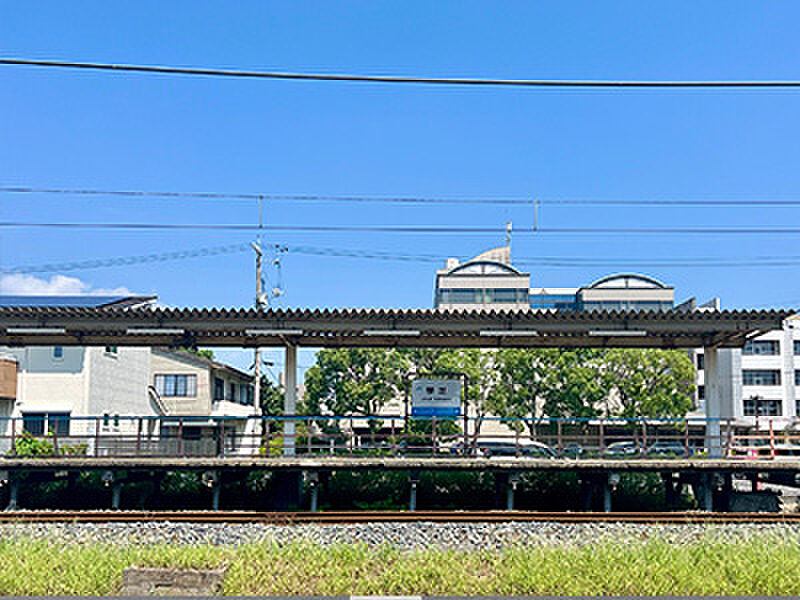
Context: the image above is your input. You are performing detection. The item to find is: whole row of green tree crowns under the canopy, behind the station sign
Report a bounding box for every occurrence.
[300,348,694,431]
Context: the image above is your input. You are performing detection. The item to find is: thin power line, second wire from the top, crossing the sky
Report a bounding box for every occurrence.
[0,186,800,206]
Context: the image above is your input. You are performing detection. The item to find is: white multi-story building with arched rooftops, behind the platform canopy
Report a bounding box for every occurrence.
[436,247,800,429]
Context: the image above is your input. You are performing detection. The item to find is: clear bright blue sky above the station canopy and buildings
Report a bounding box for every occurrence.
[0,1,800,370]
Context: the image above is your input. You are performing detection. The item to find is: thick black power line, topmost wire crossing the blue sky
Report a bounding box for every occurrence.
[0,58,800,89]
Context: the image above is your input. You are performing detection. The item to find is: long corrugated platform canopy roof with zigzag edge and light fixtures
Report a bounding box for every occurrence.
[0,306,794,348]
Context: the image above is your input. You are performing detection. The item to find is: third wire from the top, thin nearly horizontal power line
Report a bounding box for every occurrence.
[0,221,800,235]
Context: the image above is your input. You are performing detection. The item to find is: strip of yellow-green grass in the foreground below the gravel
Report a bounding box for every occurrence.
[0,536,800,595]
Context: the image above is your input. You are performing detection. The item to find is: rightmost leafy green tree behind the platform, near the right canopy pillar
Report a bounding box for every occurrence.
[603,348,695,417]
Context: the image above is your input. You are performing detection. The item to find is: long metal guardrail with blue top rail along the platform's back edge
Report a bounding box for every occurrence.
[0,415,780,460]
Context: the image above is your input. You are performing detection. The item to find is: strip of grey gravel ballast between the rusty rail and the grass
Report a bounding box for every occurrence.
[0,522,800,550]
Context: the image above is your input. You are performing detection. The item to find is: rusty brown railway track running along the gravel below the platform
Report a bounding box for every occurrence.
[0,511,800,525]
